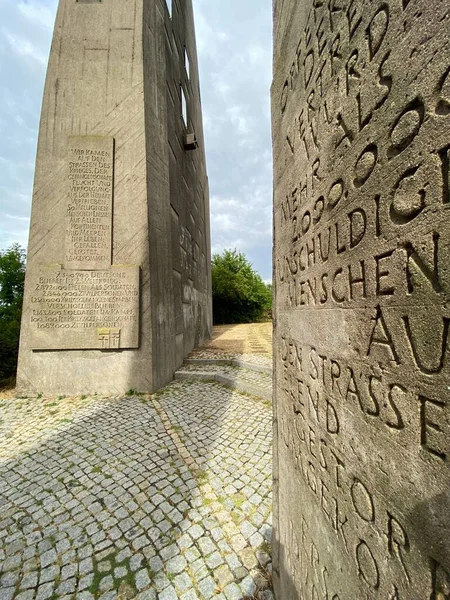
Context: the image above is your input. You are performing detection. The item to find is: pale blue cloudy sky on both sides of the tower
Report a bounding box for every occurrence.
[0,0,272,281]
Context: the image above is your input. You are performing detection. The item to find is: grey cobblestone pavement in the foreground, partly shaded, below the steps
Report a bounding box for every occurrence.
[0,382,272,600]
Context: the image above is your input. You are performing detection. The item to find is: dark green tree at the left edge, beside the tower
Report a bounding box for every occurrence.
[0,244,25,383]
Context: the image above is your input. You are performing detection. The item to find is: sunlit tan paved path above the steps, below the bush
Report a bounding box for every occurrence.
[204,322,272,357]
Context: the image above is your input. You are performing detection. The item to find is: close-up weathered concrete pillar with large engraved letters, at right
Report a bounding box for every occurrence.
[272,0,450,600]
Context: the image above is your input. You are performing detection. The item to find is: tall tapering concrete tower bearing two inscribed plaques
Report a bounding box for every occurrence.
[18,0,211,394]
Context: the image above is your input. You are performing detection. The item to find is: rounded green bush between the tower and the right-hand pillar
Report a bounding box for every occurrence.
[212,250,272,324]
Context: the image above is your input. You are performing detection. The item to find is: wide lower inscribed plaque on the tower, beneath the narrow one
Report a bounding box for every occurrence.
[30,267,139,350]
